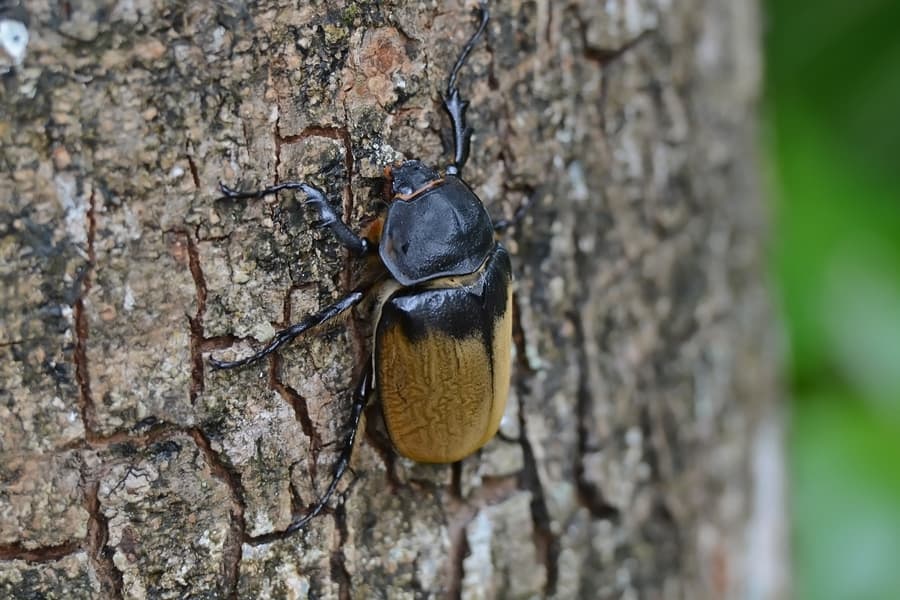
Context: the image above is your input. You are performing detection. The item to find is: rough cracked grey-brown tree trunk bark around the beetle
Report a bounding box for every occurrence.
[0,0,774,598]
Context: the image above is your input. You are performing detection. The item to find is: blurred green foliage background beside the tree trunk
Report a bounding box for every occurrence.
[763,0,900,600]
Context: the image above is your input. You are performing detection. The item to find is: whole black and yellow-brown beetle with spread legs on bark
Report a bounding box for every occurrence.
[210,3,521,532]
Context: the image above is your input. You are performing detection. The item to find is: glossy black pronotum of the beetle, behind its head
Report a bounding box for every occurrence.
[378,175,496,286]
